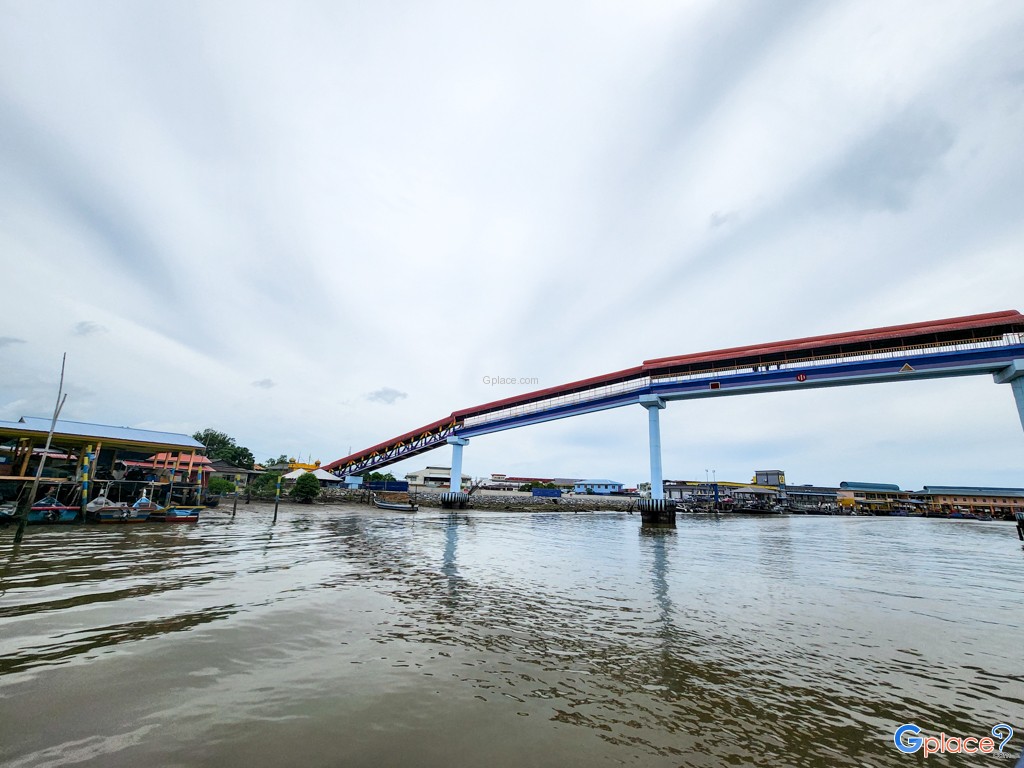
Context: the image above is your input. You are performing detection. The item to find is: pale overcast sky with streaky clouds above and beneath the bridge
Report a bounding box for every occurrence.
[0,0,1024,488]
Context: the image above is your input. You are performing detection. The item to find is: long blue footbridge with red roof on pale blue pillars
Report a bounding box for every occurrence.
[324,310,1024,519]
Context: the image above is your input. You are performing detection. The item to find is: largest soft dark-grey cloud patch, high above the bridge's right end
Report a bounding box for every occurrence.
[825,113,955,213]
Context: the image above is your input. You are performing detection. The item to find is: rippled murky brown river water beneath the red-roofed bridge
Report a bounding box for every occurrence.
[0,504,1024,768]
